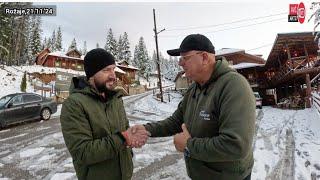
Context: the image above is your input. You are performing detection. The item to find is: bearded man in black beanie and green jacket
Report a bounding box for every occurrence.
[60,48,148,180]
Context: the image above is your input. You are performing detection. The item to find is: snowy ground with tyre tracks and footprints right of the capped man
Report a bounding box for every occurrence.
[252,107,320,180]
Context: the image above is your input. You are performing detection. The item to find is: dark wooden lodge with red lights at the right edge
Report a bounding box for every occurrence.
[259,32,320,107]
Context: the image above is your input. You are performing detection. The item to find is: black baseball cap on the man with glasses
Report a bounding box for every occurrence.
[167,34,215,56]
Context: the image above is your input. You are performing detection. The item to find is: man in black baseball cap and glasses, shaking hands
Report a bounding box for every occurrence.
[133,34,255,180]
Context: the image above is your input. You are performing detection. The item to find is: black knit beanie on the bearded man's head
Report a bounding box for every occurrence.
[84,48,115,79]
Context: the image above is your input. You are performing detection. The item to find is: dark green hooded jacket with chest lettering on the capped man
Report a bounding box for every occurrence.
[145,58,255,180]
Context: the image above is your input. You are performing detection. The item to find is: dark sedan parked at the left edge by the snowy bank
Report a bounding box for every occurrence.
[0,93,57,128]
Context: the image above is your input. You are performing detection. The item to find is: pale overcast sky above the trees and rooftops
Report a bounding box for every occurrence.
[35,1,313,58]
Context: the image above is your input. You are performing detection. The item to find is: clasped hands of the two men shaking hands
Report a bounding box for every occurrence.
[121,125,151,148]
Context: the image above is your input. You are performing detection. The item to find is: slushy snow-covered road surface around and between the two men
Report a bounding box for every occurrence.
[0,94,320,180]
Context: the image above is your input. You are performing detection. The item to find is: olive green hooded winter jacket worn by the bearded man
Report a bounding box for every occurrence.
[60,78,133,180]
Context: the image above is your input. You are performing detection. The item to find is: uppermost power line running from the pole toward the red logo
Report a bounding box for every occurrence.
[166,13,287,31]
